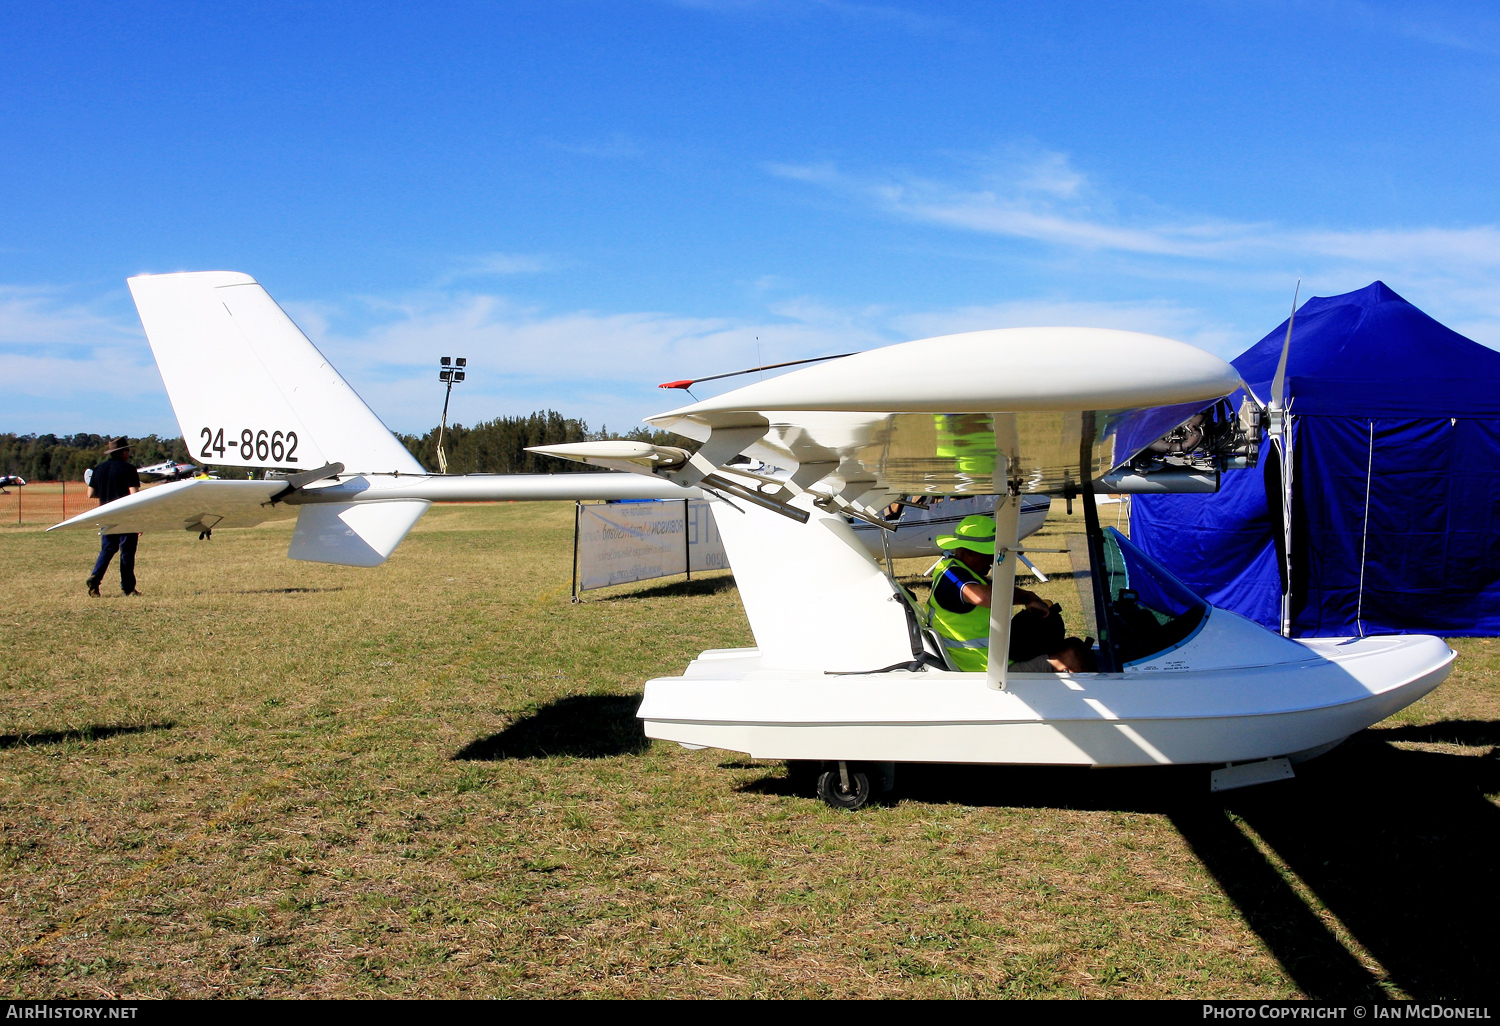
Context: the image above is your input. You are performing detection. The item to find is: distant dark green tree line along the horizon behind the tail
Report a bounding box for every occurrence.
[0,410,698,482]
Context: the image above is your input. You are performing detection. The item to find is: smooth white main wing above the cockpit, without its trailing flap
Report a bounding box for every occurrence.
[647,327,1239,495]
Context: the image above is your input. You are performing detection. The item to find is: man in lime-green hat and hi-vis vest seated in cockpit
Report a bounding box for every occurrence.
[927,515,1083,674]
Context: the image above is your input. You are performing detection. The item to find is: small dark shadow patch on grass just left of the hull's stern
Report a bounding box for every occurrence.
[453,695,651,762]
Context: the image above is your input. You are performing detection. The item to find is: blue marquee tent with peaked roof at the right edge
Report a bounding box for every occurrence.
[1131,282,1500,638]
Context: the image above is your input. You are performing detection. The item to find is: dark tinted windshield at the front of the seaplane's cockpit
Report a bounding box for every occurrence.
[1104,528,1209,666]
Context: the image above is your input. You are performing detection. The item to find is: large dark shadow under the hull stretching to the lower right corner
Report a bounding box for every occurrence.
[741,720,1500,1001]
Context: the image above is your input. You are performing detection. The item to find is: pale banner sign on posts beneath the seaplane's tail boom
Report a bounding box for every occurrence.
[578,500,729,591]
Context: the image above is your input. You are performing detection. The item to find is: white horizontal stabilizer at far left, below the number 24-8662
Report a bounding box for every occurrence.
[47,479,297,534]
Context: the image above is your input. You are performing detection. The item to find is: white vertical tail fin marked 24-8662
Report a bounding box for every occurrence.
[129,272,425,474]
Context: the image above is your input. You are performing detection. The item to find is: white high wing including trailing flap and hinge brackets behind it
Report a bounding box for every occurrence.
[537,327,1259,519]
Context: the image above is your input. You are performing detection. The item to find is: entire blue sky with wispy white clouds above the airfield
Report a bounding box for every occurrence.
[0,0,1500,434]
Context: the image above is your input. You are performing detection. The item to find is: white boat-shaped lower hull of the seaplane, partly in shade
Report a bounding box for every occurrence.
[639,633,1454,767]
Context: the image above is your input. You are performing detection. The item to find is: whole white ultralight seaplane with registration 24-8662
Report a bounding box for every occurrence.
[53,272,1454,807]
